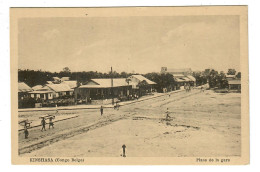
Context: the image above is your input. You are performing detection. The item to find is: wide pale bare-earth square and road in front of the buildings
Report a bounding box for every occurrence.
[19,89,241,157]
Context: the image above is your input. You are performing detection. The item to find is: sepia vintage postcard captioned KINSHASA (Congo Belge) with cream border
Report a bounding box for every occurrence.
[10,6,249,165]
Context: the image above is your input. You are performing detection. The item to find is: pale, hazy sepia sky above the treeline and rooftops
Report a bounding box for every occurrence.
[18,16,240,73]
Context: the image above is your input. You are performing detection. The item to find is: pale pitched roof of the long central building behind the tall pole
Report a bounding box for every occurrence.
[79,78,128,88]
